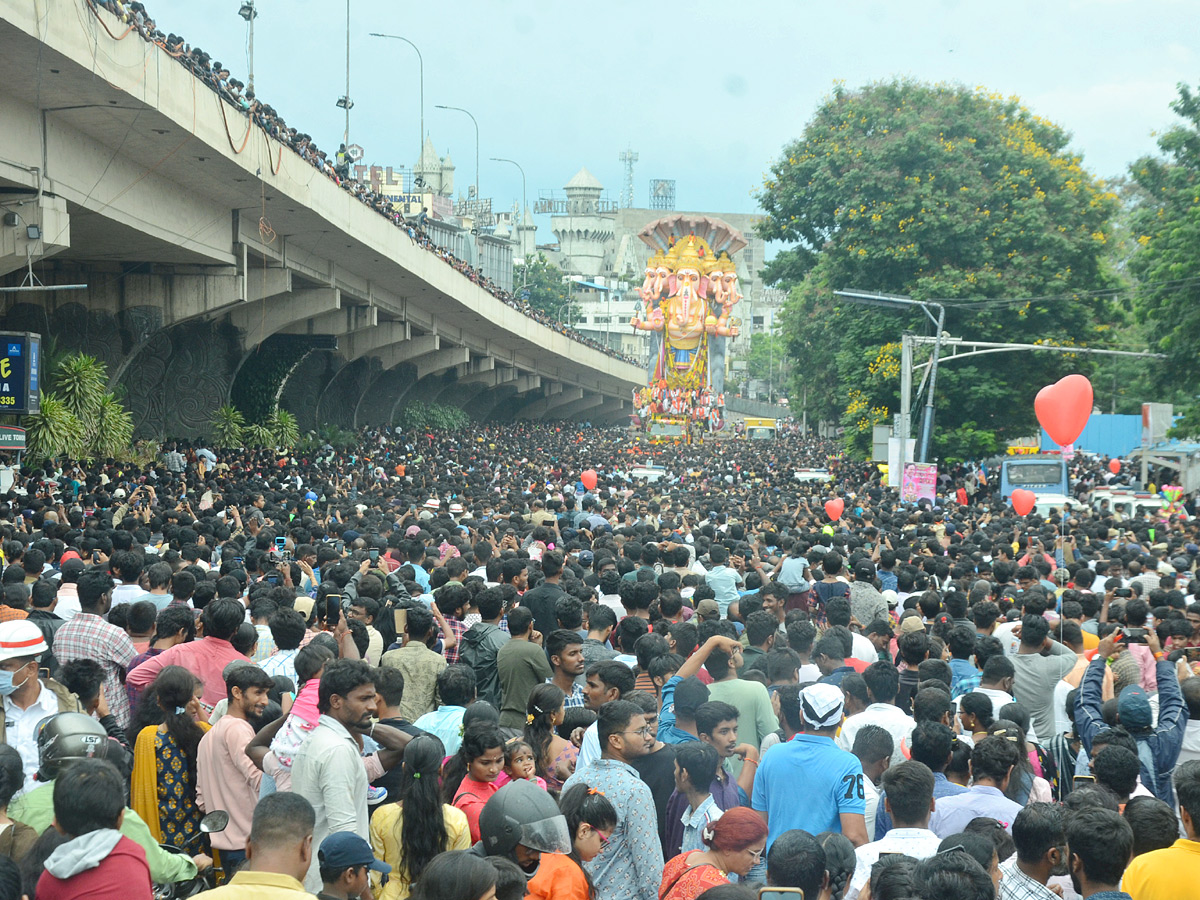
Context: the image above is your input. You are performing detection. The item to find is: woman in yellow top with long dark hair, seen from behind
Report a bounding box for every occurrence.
[371,734,470,900]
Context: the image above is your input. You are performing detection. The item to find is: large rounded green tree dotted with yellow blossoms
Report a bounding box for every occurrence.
[758,80,1120,456]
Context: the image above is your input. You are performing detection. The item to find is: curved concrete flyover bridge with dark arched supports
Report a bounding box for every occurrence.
[0,0,644,437]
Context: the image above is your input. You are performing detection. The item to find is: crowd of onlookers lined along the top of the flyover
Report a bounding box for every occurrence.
[83,0,641,365]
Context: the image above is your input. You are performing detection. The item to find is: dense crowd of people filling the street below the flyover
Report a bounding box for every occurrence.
[0,424,1200,900]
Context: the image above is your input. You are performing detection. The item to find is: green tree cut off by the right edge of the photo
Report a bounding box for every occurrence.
[1129,84,1200,437]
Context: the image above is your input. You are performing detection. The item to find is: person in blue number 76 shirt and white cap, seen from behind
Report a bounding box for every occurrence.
[750,684,869,850]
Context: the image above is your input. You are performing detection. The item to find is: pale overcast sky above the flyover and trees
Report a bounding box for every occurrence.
[146,0,1200,241]
